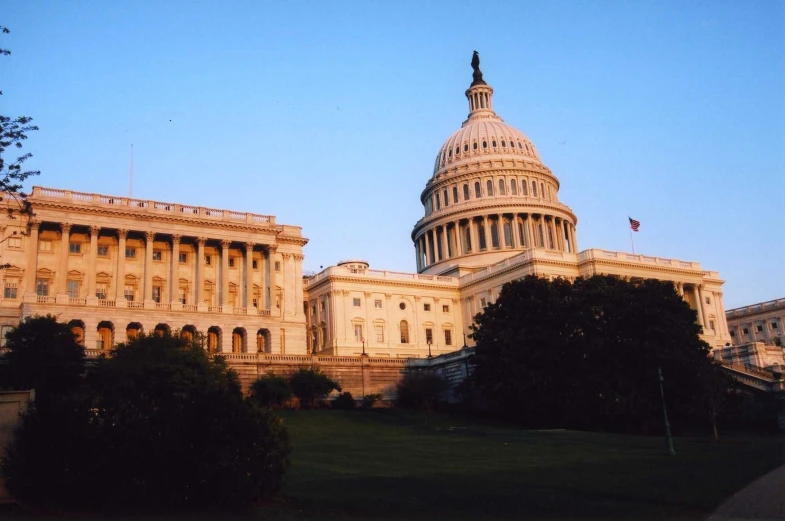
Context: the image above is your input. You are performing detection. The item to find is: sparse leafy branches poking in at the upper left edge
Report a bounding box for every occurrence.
[0,26,40,254]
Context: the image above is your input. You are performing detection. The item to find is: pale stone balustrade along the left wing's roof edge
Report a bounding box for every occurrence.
[30,186,275,227]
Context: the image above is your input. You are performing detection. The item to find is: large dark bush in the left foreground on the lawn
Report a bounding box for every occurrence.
[2,335,289,508]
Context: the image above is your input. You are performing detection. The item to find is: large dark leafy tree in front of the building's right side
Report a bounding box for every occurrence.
[473,276,719,432]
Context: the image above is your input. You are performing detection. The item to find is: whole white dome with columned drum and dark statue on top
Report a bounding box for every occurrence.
[412,54,578,273]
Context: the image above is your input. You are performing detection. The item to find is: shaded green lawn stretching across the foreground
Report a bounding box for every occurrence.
[262,410,785,520]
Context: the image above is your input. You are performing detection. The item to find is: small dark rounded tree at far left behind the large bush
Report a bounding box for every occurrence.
[3,315,85,407]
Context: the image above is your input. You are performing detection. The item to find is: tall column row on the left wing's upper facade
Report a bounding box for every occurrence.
[25,222,278,315]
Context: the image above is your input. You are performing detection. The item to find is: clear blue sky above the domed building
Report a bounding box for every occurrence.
[0,0,785,308]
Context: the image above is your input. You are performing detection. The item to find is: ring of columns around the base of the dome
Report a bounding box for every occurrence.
[415,212,578,271]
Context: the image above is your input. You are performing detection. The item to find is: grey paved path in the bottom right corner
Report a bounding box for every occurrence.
[706,465,785,521]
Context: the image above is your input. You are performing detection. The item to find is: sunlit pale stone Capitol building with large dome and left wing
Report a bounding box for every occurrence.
[0,56,731,359]
